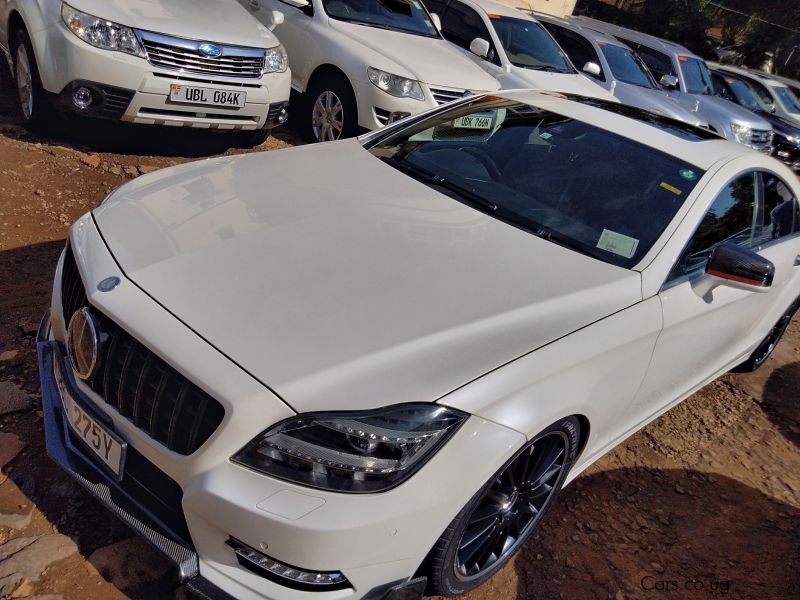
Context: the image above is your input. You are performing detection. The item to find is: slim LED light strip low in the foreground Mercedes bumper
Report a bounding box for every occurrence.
[225,538,351,591]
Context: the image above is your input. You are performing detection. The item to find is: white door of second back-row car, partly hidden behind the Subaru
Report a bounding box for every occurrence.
[239,0,319,90]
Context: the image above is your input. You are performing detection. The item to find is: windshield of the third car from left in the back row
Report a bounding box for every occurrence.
[490,15,575,73]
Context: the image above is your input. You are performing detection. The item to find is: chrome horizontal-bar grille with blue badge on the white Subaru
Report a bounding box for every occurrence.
[138,31,264,78]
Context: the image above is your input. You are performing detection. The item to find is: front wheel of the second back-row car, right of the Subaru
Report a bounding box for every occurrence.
[302,73,358,142]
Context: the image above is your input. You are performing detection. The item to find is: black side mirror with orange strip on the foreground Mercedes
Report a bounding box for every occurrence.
[695,242,775,296]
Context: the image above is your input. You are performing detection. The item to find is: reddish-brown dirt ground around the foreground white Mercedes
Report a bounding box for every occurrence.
[0,74,800,600]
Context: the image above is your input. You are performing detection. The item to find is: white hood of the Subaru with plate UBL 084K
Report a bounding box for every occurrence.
[69,0,278,48]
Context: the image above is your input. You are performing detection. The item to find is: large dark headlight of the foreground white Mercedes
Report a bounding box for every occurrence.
[233,404,467,493]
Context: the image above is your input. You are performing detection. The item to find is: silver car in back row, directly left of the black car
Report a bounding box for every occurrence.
[574,17,772,154]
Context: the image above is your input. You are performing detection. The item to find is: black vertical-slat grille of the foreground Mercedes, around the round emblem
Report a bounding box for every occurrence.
[61,246,225,455]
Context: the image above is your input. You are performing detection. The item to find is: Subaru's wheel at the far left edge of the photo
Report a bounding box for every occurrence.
[11,29,52,131]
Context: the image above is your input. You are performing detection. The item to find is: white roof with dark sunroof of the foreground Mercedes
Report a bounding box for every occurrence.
[492,90,755,170]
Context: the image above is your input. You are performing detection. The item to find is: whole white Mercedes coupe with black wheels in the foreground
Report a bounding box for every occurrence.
[39,91,800,599]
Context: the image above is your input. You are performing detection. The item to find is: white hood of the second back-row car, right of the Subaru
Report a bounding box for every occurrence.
[330,19,500,92]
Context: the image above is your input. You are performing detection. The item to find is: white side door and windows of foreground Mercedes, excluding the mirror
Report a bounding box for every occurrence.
[632,170,800,422]
